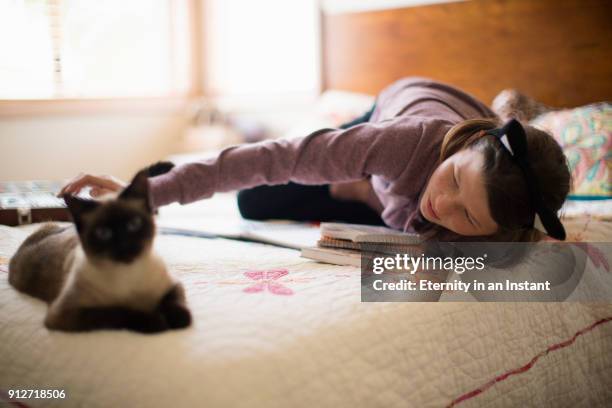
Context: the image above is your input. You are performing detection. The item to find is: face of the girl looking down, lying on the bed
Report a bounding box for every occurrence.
[419,149,498,236]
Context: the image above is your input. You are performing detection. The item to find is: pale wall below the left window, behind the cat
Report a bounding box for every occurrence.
[0,113,185,181]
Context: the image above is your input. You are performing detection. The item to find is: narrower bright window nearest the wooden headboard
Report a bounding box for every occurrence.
[205,0,320,101]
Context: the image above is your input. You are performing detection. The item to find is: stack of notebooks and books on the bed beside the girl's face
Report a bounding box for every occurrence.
[301,223,424,267]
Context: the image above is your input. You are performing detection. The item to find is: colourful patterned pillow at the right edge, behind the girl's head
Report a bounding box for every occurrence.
[530,102,612,199]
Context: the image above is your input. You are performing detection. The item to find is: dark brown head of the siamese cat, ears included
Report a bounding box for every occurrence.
[65,172,155,263]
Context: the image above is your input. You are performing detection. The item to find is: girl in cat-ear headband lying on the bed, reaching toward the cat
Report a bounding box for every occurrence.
[60,78,570,241]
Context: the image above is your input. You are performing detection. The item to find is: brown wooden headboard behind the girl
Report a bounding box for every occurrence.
[322,0,612,107]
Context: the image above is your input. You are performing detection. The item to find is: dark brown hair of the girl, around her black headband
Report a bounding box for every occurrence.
[440,119,571,242]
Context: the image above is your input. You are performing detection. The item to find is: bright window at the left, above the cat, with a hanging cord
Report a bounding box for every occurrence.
[0,0,192,99]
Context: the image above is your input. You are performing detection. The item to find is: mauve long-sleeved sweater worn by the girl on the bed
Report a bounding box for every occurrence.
[151,77,495,231]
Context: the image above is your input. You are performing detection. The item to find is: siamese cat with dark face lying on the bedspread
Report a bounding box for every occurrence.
[9,165,191,333]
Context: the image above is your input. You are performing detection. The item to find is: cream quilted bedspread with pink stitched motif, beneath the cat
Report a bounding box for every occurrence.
[0,218,612,407]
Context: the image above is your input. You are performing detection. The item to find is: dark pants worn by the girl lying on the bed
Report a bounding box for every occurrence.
[238,107,384,225]
